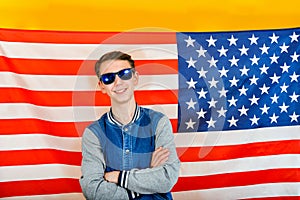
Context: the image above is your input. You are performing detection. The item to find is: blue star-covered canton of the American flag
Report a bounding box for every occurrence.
[177,28,300,132]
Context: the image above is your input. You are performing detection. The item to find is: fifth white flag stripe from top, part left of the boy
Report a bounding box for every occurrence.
[0,164,81,182]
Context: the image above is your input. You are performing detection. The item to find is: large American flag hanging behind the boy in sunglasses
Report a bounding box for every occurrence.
[0,29,300,199]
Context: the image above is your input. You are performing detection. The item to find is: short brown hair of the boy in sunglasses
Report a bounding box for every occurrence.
[95,51,135,77]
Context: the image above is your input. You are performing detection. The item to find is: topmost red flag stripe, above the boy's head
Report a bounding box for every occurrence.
[0,29,176,44]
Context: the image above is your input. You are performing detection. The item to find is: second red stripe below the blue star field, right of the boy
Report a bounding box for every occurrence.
[172,169,300,192]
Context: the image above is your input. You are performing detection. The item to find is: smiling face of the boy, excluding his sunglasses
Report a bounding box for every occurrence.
[99,60,139,104]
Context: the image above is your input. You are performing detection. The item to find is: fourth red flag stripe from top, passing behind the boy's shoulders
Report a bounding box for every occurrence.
[0,119,178,137]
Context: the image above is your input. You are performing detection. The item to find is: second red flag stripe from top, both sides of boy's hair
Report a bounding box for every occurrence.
[0,56,178,76]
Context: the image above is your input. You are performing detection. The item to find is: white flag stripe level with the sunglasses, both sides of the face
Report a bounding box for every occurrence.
[0,72,178,91]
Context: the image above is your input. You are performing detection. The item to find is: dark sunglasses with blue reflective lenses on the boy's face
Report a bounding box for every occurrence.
[99,68,134,85]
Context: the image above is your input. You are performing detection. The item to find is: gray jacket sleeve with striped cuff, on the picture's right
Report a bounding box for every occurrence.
[118,116,180,194]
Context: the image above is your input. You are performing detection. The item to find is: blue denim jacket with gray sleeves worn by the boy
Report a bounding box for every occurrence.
[80,106,180,200]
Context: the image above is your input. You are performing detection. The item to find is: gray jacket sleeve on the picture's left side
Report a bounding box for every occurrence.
[80,129,129,200]
